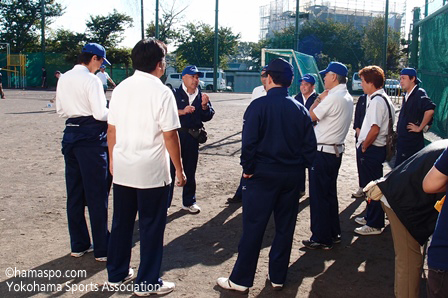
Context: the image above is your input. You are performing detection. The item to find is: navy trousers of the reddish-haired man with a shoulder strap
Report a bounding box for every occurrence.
[356,145,386,229]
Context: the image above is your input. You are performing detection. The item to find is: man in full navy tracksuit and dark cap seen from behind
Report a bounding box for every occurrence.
[217,59,316,292]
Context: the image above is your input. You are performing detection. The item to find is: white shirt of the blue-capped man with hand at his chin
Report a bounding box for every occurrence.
[313,84,353,154]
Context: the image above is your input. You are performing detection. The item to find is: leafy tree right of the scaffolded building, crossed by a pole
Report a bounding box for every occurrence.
[362,17,403,71]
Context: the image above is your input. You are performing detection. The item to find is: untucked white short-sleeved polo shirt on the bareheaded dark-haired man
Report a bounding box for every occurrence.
[108,70,180,189]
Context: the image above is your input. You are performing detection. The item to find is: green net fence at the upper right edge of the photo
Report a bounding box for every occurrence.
[418,5,448,138]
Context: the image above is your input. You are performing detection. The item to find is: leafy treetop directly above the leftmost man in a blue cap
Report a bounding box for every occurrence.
[86,9,133,48]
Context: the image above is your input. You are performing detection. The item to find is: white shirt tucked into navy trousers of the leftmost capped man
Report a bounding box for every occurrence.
[56,64,109,121]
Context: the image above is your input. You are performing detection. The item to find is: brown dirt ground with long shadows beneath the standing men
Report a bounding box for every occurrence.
[0,90,425,297]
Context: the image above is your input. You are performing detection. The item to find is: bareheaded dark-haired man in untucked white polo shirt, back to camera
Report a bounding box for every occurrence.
[107,38,185,296]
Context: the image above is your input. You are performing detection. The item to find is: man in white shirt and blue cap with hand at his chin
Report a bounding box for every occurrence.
[302,62,353,249]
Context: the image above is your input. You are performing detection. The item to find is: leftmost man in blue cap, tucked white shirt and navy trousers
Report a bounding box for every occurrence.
[56,43,111,262]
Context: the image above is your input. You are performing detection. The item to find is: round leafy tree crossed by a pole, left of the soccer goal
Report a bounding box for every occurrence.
[175,23,240,68]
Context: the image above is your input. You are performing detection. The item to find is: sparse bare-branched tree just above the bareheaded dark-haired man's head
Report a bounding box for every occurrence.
[146,1,188,44]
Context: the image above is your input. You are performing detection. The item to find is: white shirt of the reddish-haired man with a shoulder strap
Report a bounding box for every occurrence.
[356,88,395,148]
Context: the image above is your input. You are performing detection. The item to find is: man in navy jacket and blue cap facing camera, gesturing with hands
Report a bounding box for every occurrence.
[168,65,215,213]
